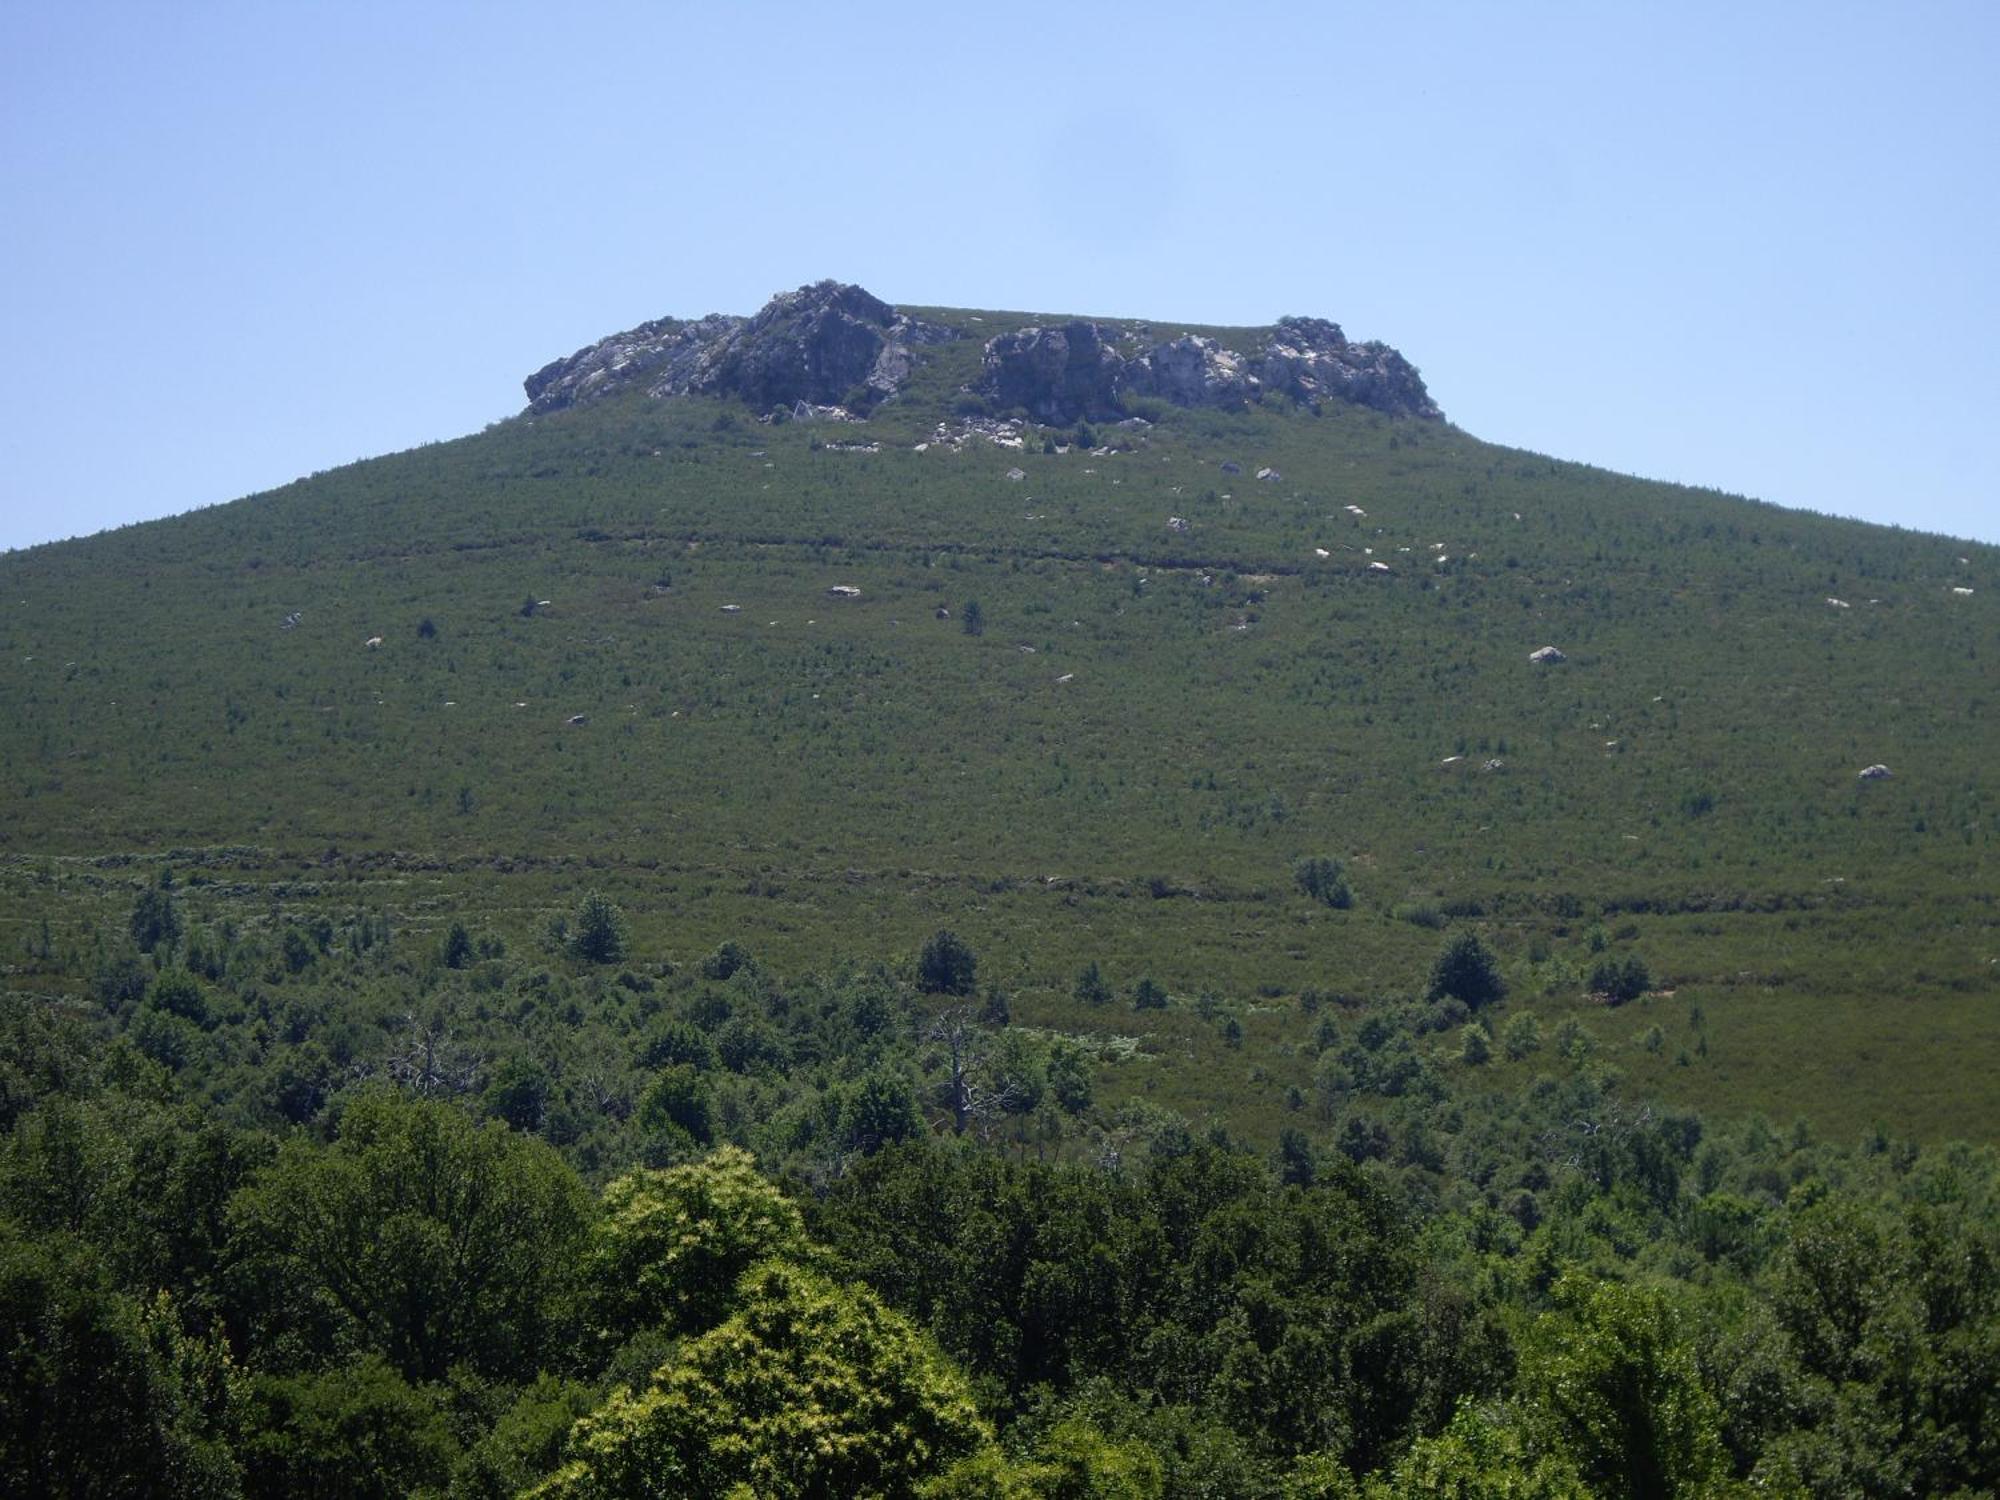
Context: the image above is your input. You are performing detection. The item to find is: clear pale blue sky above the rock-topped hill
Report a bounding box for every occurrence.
[0,0,2000,546]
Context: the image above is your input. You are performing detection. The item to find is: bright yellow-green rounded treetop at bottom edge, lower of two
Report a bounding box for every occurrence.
[528,1260,992,1500]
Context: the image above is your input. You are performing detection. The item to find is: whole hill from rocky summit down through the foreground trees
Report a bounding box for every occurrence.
[0,282,2000,1500]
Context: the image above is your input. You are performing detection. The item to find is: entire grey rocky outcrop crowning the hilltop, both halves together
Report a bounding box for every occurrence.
[524,280,1442,422]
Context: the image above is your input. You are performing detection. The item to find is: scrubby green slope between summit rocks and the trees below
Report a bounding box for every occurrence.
[0,314,2000,1138]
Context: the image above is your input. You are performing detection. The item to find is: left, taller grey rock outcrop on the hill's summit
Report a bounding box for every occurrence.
[522,282,958,420]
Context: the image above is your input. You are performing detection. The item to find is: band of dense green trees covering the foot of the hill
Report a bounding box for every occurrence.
[0,888,2000,1500]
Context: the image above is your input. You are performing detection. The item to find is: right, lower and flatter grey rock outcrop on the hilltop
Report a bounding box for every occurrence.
[978,308,1442,422]
